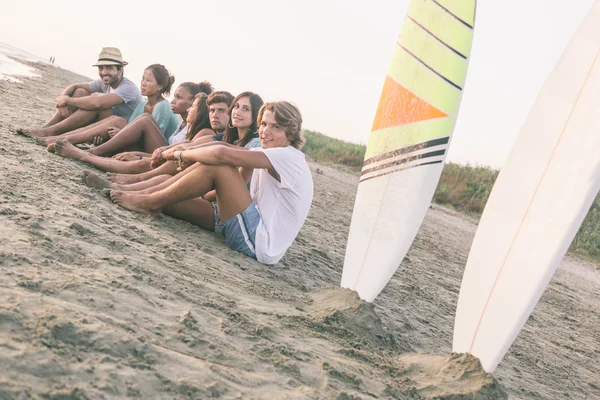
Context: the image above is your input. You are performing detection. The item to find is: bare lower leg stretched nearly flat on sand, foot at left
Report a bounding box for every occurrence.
[54,140,150,174]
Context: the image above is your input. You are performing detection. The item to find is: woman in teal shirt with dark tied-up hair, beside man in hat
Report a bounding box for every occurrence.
[38,64,180,147]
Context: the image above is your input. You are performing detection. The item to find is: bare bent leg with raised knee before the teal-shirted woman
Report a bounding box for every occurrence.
[90,114,168,156]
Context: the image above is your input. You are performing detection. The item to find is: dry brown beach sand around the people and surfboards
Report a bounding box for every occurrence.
[0,60,600,399]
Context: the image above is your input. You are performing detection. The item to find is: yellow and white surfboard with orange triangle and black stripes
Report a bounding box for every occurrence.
[341,0,476,302]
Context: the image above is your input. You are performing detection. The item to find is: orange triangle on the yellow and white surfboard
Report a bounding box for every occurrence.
[372,76,448,132]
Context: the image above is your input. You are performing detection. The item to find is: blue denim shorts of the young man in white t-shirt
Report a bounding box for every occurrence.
[212,201,260,258]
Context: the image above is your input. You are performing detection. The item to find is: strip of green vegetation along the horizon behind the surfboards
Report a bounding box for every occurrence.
[302,131,600,263]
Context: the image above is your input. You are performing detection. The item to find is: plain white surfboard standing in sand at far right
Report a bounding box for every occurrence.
[453,2,600,372]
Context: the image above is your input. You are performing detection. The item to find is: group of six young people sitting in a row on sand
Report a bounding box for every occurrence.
[19,47,313,264]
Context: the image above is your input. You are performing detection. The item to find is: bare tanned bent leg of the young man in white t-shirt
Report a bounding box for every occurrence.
[110,164,252,225]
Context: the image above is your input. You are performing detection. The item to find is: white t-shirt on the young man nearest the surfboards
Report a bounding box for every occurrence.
[250,146,313,264]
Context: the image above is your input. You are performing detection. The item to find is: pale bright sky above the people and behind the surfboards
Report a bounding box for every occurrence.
[0,0,595,168]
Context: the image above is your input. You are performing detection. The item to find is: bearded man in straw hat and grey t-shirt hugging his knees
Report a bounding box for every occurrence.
[17,47,143,137]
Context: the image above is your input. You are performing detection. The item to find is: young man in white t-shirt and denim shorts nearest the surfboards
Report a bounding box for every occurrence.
[110,101,313,264]
